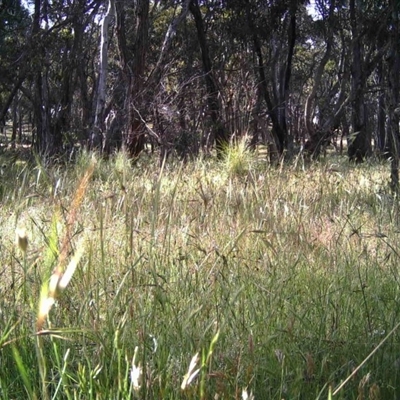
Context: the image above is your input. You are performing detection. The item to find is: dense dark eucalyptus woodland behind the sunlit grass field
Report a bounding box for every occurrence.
[0,0,400,170]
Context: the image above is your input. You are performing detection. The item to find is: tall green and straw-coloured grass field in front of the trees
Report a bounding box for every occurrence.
[0,148,400,400]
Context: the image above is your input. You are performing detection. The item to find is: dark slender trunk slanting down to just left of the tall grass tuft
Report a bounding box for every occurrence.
[189,0,229,157]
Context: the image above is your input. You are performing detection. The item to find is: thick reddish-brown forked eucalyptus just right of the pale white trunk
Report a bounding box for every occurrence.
[108,0,195,156]
